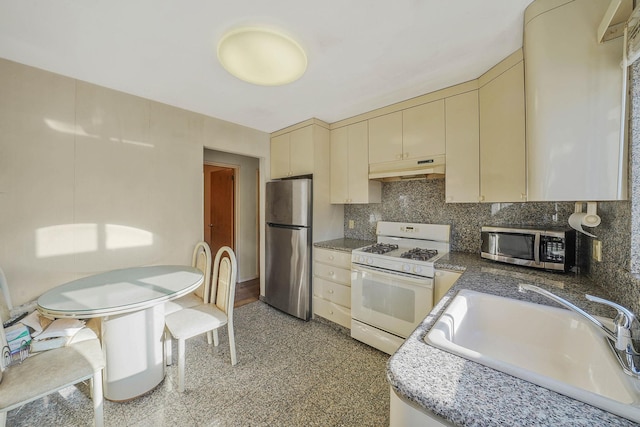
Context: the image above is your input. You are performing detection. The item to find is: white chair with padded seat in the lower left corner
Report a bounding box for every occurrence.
[0,270,105,427]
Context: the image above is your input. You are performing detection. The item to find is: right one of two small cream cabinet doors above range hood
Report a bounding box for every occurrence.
[402,99,445,159]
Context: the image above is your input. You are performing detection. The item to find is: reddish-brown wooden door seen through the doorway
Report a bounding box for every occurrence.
[204,165,235,257]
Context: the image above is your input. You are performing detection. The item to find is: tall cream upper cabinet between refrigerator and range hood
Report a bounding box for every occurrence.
[331,121,381,203]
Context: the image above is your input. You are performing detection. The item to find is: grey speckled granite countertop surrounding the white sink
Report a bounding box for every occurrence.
[387,252,637,426]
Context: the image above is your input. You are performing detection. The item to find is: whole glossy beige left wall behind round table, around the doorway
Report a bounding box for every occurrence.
[0,59,269,305]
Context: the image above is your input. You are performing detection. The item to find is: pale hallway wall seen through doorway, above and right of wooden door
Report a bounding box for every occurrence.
[204,150,260,282]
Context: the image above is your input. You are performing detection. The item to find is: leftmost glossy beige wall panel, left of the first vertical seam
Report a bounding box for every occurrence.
[0,59,75,305]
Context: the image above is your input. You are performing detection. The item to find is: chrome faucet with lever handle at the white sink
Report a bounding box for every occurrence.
[518,284,640,378]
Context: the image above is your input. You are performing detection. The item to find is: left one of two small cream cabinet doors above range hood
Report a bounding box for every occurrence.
[369,111,402,164]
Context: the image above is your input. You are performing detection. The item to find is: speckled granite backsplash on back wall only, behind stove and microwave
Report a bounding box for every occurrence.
[344,178,574,253]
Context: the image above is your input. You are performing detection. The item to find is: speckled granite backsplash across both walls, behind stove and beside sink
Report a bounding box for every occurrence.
[344,179,640,314]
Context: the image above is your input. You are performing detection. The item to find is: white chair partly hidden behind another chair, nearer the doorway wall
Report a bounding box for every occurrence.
[164,242,212,365]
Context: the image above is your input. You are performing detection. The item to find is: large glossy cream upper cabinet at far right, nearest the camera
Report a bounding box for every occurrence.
[524,0,628,201]
